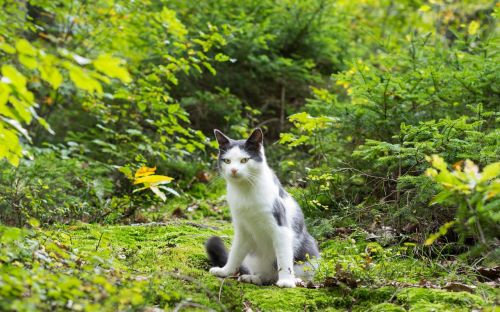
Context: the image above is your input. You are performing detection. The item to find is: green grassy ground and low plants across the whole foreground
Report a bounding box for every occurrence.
[0,219,498,311]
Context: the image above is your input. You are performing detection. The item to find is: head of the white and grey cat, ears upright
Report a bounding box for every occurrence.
[214,129,266,182]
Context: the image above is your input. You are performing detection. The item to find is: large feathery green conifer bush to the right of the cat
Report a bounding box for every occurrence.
[280,3,500,251]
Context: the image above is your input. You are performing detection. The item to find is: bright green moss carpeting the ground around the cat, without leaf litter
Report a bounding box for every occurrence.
[3,220,498,311]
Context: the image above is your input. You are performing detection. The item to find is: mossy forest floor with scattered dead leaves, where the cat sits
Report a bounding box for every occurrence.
[35,219,500,311]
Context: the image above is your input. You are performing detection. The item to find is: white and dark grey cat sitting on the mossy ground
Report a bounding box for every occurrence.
[205,128,319,287]
